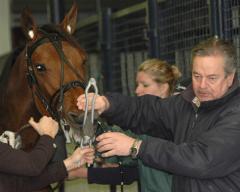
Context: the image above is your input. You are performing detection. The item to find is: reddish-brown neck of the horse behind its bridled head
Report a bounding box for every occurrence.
[0,56,38,133]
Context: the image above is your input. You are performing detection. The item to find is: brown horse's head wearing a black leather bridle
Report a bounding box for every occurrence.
[19,4,94,144]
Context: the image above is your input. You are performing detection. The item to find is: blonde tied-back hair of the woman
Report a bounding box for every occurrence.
[138,59,182,94]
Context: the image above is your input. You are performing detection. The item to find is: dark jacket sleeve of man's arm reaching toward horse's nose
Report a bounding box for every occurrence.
[102,94,171,139]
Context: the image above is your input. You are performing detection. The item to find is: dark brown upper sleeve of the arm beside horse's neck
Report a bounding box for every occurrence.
[0,135,54,176]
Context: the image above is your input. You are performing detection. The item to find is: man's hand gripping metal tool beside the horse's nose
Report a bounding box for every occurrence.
[77,93,109,115]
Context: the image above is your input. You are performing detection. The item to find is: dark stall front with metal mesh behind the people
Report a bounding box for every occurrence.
[76,0,240,95]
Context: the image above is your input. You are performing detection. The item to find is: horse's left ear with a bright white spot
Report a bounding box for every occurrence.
[21,8,37,41]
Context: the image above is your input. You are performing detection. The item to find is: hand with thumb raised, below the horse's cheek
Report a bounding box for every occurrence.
[29,116,58,138]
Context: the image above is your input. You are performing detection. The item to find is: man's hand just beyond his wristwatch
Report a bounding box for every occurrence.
[96,132,135,157]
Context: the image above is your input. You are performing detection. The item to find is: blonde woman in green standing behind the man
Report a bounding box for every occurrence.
[133,59,181,192]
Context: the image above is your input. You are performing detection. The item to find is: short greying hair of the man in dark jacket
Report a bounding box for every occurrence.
[191,37,237,75]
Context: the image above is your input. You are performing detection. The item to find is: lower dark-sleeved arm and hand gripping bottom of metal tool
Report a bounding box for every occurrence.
[0,148,94,192]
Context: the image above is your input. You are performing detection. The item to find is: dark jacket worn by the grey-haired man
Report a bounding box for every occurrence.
[102,79,240,192]
